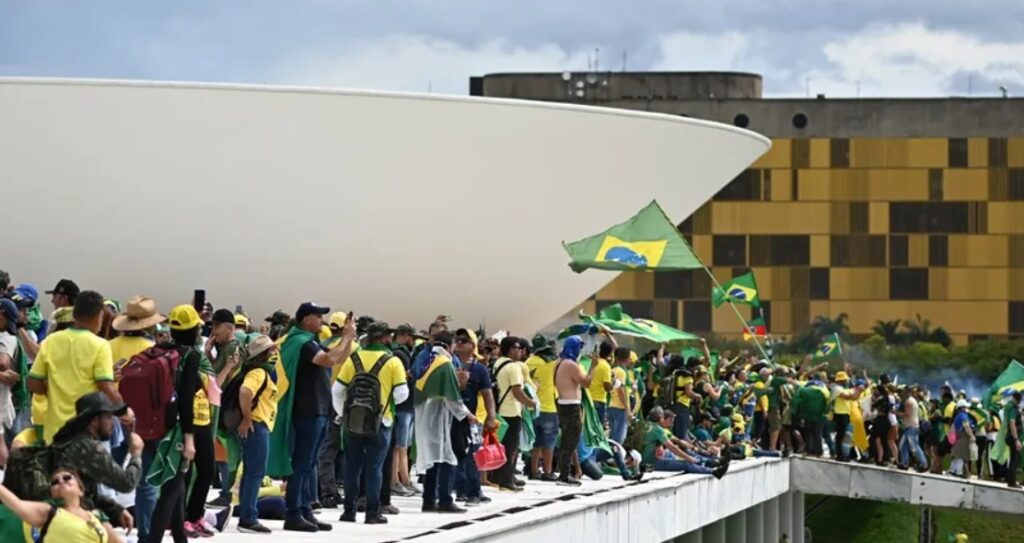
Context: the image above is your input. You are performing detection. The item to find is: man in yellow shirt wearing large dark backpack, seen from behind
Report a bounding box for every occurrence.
[332,321,409,525]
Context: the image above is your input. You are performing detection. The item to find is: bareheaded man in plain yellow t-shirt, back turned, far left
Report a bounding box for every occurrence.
[29,290,121,443]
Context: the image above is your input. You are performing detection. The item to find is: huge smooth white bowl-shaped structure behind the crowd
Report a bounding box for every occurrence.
[0,79,769,334]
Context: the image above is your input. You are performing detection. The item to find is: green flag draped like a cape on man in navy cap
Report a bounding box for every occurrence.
[266,327,316,478]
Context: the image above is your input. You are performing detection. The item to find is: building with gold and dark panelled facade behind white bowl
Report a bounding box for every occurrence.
[470,73,1024,343]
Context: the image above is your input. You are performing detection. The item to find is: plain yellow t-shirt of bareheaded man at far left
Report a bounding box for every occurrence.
[29,328,114,443]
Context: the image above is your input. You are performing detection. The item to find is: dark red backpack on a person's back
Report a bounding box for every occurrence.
[118,345,181,441]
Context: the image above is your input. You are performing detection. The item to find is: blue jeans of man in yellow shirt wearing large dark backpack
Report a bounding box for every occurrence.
[345,424,391,517]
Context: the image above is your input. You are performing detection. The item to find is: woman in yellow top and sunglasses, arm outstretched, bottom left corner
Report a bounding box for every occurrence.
[0,468,124,543]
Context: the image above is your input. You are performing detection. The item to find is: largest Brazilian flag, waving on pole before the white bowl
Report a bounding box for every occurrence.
[562,201,703,274]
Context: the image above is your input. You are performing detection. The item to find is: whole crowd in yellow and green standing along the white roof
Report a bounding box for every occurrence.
[0,272,1022,543]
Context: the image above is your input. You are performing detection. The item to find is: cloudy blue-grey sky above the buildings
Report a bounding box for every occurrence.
[0,0,1024,96]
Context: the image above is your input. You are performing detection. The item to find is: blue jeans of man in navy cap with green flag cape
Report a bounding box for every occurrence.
[288,417,327,517]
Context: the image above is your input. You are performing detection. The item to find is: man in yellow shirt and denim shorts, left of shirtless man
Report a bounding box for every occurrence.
[526,335,558,482]
